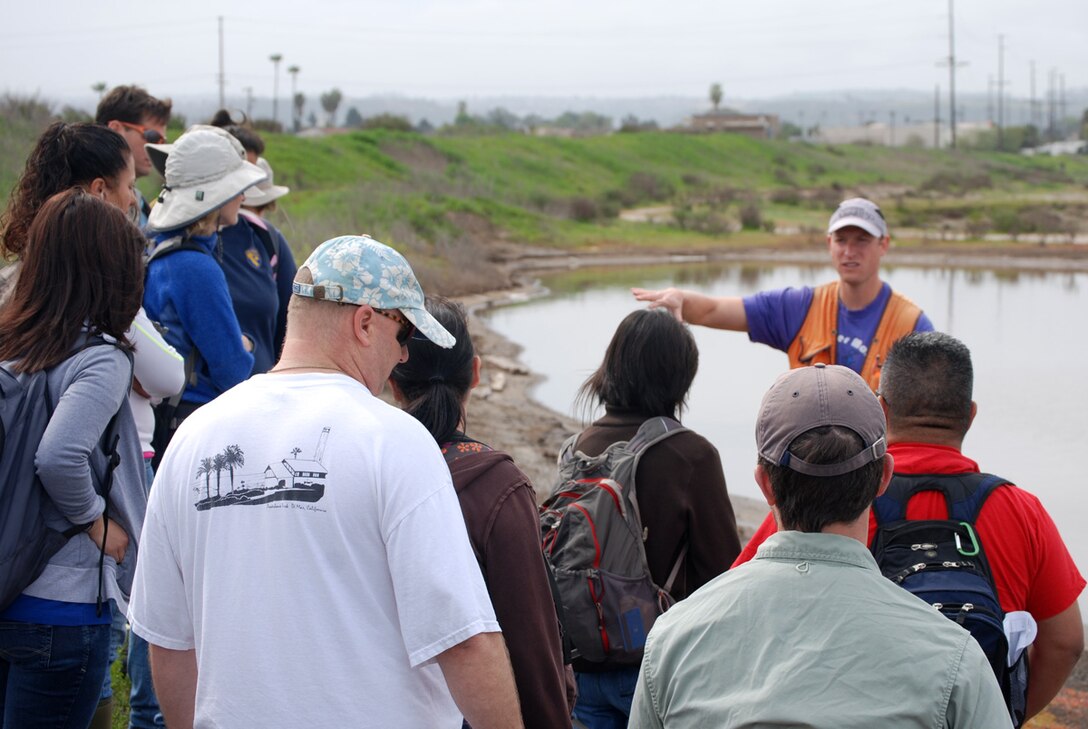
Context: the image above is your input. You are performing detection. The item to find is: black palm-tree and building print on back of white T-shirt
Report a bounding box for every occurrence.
[194,428,330,511]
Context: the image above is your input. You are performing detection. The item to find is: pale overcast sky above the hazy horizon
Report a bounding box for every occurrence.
[0,0,1088,104]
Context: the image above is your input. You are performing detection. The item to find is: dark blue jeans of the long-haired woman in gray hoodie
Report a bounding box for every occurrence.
[0,622,110,729]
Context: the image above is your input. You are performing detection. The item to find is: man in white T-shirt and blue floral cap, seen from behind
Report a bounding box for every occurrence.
[129,236,521,729]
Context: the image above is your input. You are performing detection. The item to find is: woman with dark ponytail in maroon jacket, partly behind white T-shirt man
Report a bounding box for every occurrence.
[390,297,571,729]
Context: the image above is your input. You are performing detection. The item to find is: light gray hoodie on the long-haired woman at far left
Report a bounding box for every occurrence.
[23,346,147,610]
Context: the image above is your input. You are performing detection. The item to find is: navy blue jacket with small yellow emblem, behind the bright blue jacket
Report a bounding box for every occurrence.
[219,214,297,374]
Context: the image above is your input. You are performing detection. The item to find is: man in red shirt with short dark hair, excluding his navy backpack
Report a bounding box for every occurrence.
[733,332,1085,717]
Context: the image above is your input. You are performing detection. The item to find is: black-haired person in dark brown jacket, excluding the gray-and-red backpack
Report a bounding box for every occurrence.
[573,309,740,729]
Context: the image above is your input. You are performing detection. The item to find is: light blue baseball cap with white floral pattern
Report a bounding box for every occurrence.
[292,235,457,349]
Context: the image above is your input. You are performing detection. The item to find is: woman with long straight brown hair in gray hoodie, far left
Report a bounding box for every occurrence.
[0,190,147,729]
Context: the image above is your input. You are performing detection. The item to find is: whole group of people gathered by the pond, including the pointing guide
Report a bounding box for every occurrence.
[0,81,1085,729]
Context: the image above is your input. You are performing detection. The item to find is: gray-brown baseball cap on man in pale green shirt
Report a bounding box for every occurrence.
[755,365,888,477]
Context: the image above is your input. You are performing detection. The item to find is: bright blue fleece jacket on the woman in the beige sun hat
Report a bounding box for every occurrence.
[144,231,254,405]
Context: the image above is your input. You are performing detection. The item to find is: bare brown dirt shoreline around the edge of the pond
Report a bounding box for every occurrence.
[446,247,1088,729]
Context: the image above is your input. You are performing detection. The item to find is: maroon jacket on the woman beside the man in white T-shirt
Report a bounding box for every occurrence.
[444,442,572,729]
